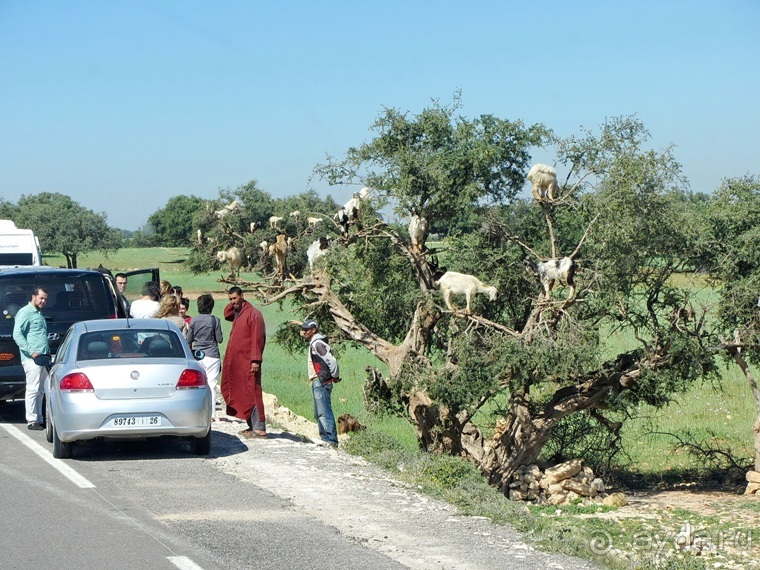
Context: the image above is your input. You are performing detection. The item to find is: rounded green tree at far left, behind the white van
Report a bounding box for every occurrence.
[15,192,122,268]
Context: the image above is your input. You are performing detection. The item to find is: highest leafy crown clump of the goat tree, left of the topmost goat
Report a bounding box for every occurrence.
[315,93,549,233]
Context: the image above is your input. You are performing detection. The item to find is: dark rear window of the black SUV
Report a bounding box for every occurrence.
[0,273,113,322]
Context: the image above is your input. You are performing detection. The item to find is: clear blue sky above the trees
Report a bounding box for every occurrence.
[0,0,760,230]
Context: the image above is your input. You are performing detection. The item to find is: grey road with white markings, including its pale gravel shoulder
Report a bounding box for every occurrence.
[0,394,592,570]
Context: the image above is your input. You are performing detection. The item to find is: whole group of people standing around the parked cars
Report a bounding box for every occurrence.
[13,273,340,447]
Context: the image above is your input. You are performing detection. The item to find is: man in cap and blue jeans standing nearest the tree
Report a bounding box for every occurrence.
[301,319,340,447]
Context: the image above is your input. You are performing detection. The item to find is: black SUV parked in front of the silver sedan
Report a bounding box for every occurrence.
[0,266,158,402]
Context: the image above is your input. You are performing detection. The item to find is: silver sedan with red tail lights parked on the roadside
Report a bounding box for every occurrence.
[45,319,211,458]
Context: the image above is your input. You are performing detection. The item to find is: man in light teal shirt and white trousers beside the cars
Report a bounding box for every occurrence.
[13,287,50,430]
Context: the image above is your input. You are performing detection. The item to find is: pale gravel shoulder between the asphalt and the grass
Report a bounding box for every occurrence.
[212,395,595,570]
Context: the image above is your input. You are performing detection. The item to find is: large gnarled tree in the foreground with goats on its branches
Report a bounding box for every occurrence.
[248,101,713,491]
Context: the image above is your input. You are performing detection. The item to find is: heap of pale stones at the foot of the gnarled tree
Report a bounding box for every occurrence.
[509,459,626,506]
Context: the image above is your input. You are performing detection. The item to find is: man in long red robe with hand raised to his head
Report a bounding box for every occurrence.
[222,287,267,438]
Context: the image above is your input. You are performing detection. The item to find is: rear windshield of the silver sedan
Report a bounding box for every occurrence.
[77,329,185,360]
